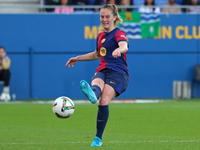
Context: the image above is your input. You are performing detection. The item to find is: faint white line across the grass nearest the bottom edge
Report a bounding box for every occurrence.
[0,140,200,145]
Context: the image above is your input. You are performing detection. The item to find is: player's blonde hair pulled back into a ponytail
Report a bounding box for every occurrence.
[101,4,123,27]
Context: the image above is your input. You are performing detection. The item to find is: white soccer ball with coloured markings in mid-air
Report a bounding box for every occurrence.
[52,96,75,118]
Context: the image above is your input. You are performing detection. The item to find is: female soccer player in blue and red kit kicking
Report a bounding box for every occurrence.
[65,4,129,146]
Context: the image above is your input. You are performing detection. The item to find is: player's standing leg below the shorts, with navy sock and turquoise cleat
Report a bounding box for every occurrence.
[91,84,117,146]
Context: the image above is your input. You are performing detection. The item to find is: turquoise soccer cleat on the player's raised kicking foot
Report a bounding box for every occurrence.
[80,80,97,104]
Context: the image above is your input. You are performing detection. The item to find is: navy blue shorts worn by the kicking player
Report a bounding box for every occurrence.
[92,68,129,96]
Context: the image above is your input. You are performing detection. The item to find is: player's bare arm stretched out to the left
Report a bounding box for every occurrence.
[65,50,100,68]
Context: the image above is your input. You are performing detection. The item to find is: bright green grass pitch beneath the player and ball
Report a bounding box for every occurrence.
[0,99,200,150]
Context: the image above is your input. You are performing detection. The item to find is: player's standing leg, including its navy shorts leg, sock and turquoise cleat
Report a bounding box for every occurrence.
[91,69,128,146]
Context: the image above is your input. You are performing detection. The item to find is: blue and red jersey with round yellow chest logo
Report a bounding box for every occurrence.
[96,28,129,76]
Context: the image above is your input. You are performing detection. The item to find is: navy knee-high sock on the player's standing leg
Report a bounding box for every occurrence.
[96,105,109,139]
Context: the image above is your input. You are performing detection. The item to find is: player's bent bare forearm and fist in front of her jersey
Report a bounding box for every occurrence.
[112,41,128,58]
